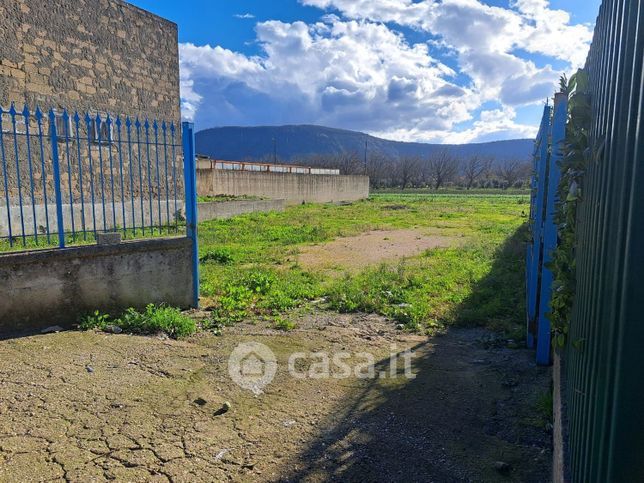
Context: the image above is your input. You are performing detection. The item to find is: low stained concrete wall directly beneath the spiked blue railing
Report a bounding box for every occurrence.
[0,237,192,334]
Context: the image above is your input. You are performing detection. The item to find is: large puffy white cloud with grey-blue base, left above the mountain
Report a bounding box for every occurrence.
[180,18,479,136]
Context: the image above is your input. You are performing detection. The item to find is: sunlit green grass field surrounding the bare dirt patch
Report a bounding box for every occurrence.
[199,194,529,332]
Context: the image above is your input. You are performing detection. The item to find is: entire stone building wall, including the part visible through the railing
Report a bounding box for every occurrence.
[0,0,183,229]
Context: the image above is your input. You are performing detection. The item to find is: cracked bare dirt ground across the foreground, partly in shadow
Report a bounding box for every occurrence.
[0,310,551,482]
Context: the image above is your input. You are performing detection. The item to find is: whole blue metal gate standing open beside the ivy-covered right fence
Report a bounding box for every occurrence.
[526,94,568,365]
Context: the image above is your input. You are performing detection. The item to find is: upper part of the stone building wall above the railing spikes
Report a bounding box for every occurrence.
[0,0,180,122]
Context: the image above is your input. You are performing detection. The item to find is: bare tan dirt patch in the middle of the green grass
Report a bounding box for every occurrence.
[298,230,459,272]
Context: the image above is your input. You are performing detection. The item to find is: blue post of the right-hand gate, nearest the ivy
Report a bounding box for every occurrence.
[537,93,568,365]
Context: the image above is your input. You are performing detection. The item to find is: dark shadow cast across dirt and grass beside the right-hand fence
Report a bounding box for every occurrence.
[280,229,551,483]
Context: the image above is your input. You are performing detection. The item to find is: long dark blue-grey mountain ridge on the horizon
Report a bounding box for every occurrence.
[196,125,534,166]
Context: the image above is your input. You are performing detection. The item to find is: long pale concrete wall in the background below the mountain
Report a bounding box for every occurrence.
[197,169,369,204]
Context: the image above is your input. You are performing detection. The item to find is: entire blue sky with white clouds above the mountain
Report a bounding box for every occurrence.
[131,0,601,143]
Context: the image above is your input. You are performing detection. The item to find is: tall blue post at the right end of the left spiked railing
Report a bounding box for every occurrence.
[182,122,199,308]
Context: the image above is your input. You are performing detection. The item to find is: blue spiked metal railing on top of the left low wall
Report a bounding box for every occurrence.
[0,105,187,251]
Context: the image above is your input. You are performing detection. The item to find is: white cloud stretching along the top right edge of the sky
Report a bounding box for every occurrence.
[300,0,593,68]
